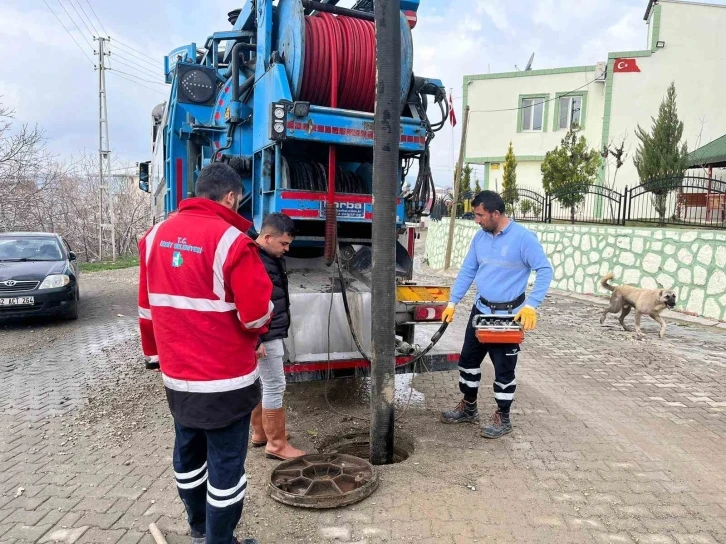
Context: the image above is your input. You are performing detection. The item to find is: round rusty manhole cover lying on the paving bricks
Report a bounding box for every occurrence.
[269,453,378,508]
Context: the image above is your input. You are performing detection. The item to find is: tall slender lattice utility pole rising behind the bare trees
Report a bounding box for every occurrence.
[94,36,116,261]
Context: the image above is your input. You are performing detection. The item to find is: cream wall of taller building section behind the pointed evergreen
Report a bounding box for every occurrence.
[609,0,726,187]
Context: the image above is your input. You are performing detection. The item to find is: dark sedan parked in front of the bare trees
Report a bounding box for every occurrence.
[0,232,80,319]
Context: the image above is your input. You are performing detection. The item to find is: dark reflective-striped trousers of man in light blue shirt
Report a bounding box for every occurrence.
[459,304,519,414]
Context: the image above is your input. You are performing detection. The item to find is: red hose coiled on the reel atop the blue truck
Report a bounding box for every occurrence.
[300,13,376,112]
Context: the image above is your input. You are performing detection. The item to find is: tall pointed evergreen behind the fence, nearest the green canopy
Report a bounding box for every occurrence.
[633,83,688,225]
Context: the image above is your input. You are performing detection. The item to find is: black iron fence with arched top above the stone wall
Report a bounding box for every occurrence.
[494,176,726,229]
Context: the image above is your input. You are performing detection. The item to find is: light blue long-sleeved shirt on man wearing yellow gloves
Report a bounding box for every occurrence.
[451,220,552,314]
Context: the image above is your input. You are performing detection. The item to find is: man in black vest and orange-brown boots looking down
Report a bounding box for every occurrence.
[251,213,305,459]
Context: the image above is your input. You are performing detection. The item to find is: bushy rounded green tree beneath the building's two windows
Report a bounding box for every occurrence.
[541,127,601,223]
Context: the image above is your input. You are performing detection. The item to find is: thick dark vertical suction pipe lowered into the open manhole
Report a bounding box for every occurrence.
[370,0,401,465]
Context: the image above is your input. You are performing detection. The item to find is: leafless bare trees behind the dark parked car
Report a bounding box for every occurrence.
[0,105,151,261]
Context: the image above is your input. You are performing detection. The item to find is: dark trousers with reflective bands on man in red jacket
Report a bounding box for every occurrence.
[174,415,250,544]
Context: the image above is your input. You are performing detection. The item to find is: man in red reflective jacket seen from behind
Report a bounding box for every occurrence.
[139,163,273,544]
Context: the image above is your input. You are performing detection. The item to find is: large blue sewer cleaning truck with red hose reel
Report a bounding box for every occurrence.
[139,0,458,381]
